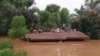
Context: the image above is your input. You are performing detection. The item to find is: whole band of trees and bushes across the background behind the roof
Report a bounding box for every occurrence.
[0,0,100,39]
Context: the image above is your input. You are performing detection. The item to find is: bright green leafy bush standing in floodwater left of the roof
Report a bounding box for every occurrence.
[8,16,28,38]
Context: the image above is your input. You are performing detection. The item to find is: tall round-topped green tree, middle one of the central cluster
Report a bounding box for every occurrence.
[46,4,61,27]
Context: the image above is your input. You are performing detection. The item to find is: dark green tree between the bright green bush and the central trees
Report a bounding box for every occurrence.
[21,8,39,29]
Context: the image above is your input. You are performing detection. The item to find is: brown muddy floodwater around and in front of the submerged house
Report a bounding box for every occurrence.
[0,38,100,56]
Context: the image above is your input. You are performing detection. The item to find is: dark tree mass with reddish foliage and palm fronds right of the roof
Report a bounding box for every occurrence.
[72,0,100,39]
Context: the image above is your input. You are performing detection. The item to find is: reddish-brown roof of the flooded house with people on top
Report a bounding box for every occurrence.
[26,31,89,40]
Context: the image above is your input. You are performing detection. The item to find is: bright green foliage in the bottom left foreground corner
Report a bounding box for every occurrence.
[0,39,26,56]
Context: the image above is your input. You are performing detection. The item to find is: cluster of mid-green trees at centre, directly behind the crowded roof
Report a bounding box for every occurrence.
[39,4,69,28]
